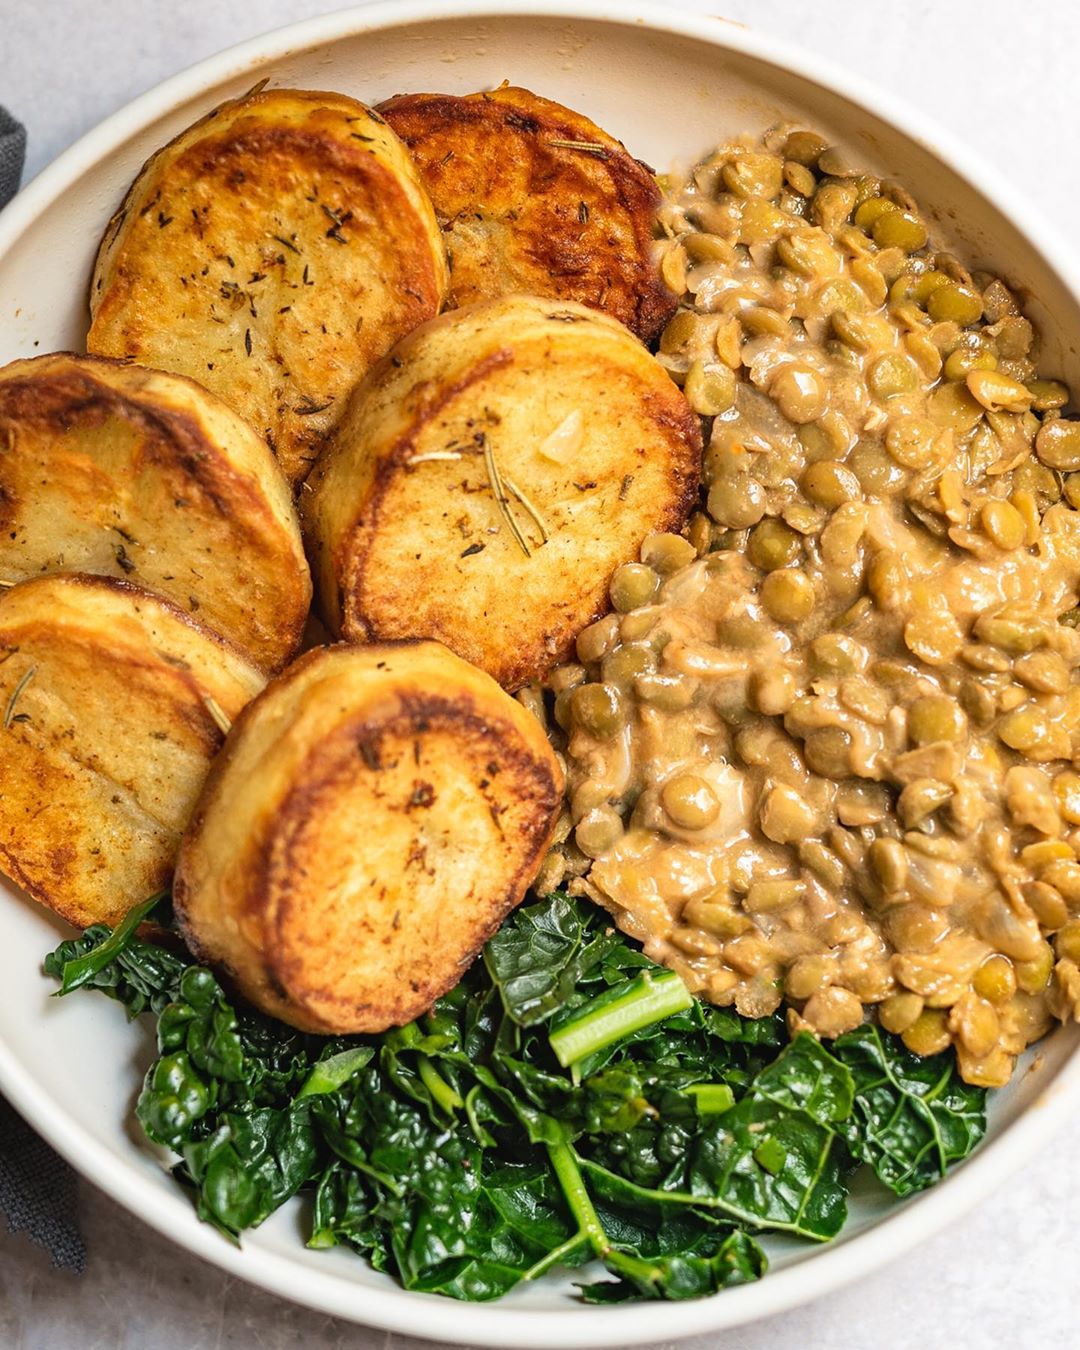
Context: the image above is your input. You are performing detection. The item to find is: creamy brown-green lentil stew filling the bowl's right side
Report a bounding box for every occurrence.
[522,130,1080,1085]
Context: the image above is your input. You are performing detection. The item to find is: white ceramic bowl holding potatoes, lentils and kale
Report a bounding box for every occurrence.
[0,0,1080,1347]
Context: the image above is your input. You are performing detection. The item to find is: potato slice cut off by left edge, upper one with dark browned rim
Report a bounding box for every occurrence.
[0,352,312,671]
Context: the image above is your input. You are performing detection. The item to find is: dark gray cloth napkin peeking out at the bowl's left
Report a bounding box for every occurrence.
[0,108,86,1272]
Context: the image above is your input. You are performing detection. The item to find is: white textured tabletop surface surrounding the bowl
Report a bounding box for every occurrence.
[0,0,1080,1350]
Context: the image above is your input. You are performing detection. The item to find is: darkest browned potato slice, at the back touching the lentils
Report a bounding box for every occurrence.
[379,85,676,342]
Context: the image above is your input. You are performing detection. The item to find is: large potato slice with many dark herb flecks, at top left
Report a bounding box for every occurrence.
[86,89,447,483]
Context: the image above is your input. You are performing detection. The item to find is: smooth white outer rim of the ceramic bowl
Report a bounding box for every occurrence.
[0,0,1080,1350]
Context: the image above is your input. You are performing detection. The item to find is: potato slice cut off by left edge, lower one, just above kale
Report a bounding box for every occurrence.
[0,572,263,927]
